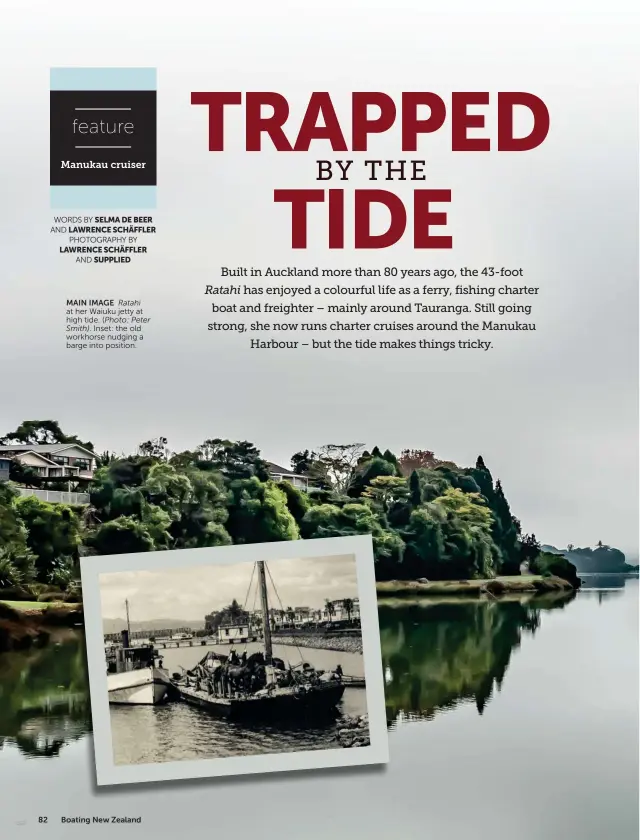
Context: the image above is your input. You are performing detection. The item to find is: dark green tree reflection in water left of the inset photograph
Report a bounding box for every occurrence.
[0,630,91,758]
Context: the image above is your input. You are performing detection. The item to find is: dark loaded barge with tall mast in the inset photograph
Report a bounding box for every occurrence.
[173,560,345,721]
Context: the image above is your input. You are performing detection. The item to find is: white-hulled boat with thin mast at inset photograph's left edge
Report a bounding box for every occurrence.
[105,602,173,706]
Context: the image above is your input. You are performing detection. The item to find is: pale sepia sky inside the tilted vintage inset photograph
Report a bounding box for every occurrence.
[100,554,358,621]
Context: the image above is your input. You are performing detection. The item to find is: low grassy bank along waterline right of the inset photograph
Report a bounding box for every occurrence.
[376,575,573,598]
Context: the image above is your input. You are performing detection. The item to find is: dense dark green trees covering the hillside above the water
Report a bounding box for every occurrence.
[0,421,564,588]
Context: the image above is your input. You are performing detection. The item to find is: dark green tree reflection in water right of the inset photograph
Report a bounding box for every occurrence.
[379,593,575,726]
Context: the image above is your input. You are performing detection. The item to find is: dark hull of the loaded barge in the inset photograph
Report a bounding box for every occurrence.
[176,682,345,721]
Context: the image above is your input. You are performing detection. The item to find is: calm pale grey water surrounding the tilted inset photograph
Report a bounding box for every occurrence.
[0,576,638,840]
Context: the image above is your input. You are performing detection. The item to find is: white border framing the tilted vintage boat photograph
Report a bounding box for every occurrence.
[80,535,389,786]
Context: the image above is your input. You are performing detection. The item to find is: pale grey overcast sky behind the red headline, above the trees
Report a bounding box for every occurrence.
[0,24,639,553]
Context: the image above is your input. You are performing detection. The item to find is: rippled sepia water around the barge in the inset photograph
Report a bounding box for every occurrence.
[110,644,367,764]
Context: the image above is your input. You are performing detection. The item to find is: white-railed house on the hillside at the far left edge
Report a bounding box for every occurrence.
[0,443,98,481]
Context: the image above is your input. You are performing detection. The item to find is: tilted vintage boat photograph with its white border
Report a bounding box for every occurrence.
[82,537,388,784]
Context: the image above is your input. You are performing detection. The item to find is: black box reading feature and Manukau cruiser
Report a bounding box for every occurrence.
[50,90,157,186]
